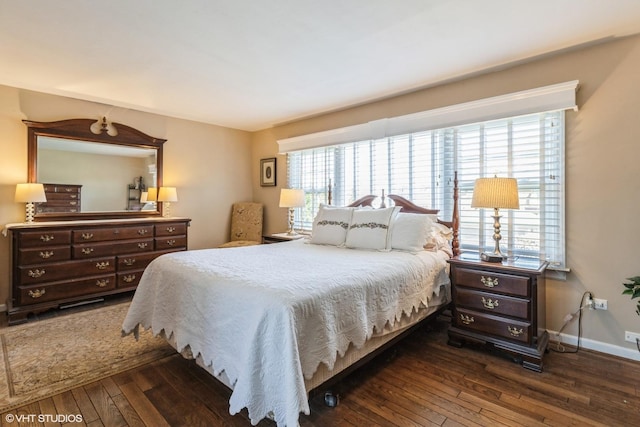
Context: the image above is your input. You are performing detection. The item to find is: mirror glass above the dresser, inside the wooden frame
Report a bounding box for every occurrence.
[36,135,157,213]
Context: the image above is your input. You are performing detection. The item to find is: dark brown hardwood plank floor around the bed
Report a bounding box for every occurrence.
[1,321,640,427]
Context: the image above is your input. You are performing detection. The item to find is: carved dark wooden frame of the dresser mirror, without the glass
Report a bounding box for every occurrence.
[23,118,167,222]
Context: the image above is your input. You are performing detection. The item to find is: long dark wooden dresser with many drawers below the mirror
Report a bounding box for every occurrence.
[5,217,191,325]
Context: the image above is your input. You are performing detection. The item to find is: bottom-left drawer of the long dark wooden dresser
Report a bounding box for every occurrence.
[19,274,116,305]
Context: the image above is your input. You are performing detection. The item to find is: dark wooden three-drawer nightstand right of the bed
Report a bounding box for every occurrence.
[449,254,549,372]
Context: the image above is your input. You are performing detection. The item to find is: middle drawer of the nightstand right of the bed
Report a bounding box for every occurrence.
[454,288,531,320]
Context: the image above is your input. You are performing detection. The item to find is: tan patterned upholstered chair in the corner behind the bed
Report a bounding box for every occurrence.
[220,202,263,248]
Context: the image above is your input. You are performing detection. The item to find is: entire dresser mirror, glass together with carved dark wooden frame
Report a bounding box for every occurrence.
[24,118,166,221]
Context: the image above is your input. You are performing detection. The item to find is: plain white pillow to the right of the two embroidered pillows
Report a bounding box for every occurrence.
[391,212,433,252]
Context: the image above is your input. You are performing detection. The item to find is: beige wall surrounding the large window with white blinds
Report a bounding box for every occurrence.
[252,36,640,360]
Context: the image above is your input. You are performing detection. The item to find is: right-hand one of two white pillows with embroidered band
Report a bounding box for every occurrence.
[345,207,400,251]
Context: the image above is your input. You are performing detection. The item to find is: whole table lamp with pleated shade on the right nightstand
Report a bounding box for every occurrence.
[471,177,520,262]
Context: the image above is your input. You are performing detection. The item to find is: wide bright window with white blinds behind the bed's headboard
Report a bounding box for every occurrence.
[287,110,565,268]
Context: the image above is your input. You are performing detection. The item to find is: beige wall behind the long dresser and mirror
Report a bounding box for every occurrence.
[0,86,255,303]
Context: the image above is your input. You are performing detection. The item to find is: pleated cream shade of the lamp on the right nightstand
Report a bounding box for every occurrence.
[471,177,520,209]
